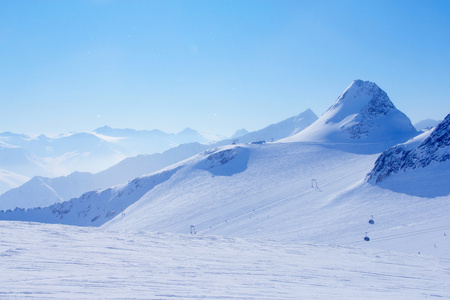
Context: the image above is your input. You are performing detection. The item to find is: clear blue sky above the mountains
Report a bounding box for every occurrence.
[0,0,450,136]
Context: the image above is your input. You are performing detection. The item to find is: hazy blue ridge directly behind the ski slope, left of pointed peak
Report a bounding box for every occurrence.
[0,110,317,210]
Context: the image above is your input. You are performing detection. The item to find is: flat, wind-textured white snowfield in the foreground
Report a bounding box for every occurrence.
[0,221,450,299]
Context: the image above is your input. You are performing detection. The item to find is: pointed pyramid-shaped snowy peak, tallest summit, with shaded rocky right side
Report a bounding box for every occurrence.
[284,80,417,145]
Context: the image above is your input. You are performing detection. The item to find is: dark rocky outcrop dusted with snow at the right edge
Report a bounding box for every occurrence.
[368,114,450,183]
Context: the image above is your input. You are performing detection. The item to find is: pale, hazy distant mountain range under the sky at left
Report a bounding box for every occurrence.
[0,126,215,193]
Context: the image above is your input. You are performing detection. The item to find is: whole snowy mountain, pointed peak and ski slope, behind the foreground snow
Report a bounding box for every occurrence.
[0,81,450,256]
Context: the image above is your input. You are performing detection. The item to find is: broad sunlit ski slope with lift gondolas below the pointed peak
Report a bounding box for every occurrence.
[100,143,450,257]
